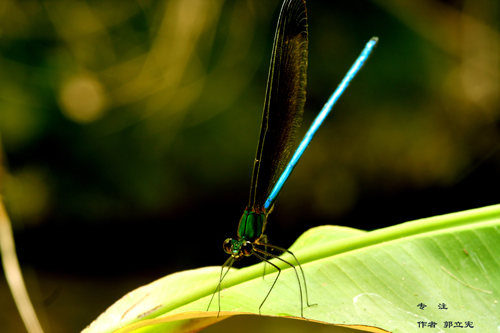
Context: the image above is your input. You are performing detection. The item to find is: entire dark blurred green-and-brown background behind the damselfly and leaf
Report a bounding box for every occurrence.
[0,0,500,333]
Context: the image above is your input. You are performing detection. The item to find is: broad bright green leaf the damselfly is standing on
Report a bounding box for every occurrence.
[83,205,500,333]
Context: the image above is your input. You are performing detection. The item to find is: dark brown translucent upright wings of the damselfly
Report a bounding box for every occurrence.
[249,0,308,209]
